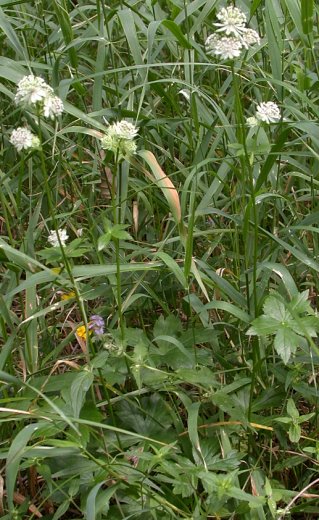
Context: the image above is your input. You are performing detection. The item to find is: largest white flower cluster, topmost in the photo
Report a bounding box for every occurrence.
[205,6,260,60]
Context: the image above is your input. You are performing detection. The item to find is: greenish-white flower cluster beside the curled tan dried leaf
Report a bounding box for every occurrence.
[101,120,138,159]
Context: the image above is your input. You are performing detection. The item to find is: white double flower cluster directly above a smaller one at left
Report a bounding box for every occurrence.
[15,74,64,119]
